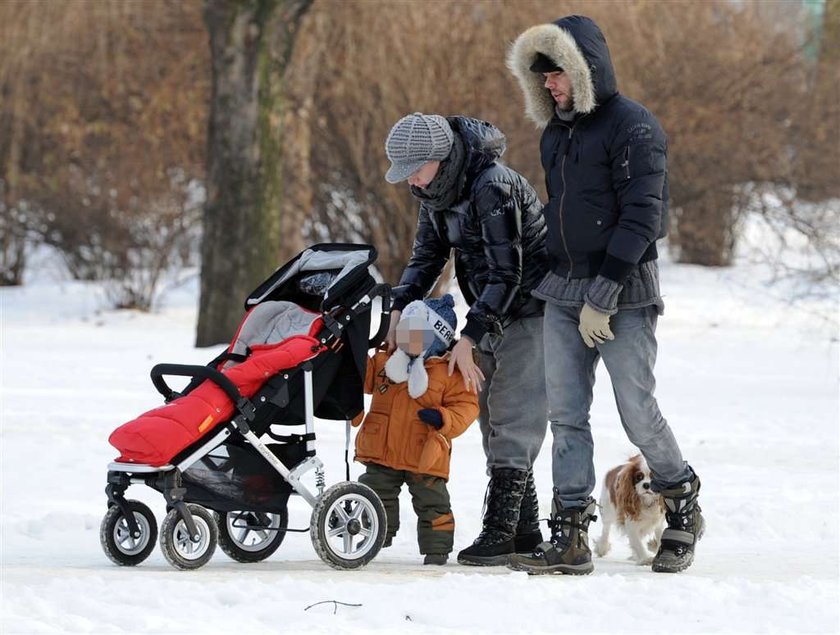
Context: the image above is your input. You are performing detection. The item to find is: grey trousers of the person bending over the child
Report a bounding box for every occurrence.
[476,316,548,470]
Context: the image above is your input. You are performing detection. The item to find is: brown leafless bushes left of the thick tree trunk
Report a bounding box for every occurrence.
[0,0,209,309]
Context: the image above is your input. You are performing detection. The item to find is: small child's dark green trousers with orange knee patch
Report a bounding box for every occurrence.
[359,463,455,554]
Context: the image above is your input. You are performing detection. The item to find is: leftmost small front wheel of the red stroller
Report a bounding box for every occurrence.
[99,500,157,567]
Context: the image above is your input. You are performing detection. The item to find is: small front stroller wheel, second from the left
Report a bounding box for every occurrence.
[160,505,218,569]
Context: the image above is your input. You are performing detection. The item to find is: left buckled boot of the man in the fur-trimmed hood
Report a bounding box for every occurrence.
[508,497,596,575]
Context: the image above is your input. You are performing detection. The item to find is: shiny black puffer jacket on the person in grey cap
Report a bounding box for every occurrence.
[393,117,547,342]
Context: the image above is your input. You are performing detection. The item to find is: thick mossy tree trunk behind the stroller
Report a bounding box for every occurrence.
[196,0,311,346]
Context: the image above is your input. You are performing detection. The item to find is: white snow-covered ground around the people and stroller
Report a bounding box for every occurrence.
[0,241,840,635]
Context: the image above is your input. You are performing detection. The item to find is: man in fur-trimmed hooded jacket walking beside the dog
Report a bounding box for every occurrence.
[508,16,704,574]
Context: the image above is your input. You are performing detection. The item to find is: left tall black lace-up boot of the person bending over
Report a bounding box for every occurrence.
[458,468,528,567]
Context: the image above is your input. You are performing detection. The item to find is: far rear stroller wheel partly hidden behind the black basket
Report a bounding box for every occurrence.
[215,510,289,562]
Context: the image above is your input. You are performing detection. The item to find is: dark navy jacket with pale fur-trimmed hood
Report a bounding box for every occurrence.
[510,16,668,283]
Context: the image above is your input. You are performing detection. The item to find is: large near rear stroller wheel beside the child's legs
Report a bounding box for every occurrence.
[309,482,386,569]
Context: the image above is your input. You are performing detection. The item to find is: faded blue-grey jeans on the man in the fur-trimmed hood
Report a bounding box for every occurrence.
[545,303,692,507]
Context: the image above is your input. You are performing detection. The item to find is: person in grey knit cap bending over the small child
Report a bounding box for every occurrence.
[385,113,547,566]
